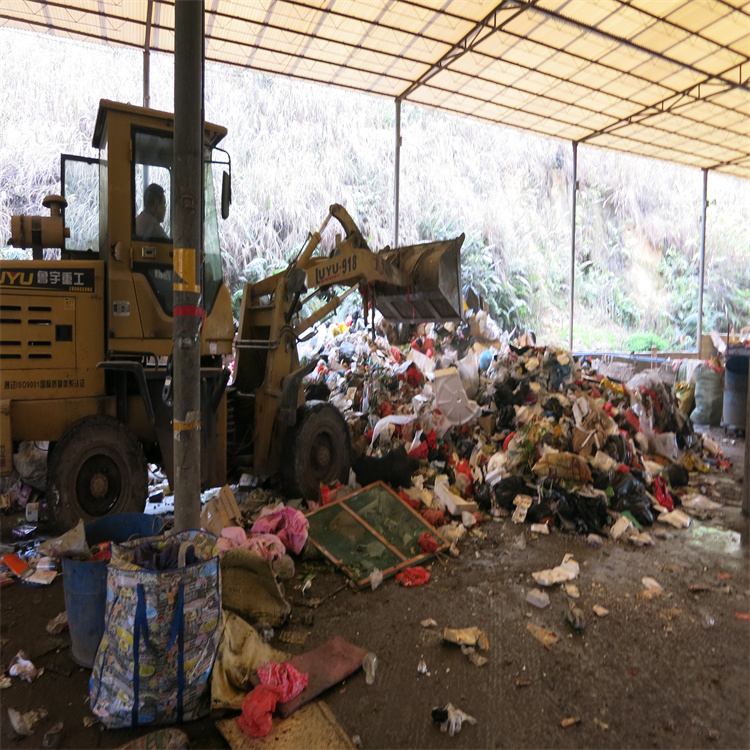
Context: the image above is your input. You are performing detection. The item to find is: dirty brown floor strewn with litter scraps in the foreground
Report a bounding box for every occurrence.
[0,430,750,750]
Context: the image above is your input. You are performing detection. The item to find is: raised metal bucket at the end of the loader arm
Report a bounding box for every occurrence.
[375,234,464,323]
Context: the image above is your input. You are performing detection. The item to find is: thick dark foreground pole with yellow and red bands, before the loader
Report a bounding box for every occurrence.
[172,0,205,531]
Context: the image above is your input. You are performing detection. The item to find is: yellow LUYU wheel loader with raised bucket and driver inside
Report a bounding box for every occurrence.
[0,100,463,528]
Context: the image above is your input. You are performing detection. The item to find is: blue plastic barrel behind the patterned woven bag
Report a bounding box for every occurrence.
[62,513,164,669]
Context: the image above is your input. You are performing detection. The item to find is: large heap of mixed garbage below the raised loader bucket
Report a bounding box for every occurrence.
[301,312,727,544]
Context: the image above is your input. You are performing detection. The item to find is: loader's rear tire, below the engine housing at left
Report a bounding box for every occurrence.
[47,415,148,530]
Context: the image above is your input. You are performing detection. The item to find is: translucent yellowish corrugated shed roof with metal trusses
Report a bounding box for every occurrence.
[0,0,750,178]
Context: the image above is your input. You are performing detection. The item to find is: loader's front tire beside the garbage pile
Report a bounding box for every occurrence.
[283,401,352,500]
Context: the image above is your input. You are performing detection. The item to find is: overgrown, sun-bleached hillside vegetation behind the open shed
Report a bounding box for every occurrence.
[0,30,750,351]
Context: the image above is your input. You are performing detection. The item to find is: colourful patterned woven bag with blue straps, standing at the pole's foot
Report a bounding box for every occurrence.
[89,531,221,728]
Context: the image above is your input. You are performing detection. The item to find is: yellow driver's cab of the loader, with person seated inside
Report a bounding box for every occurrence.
[83,100,234,357]
